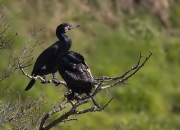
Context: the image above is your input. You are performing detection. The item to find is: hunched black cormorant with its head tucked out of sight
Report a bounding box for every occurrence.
[58,51,100,107]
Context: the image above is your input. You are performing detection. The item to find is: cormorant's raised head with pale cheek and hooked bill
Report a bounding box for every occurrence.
[56,23,80,36]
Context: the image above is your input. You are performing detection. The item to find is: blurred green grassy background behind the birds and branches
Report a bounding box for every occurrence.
[0,0,180,130]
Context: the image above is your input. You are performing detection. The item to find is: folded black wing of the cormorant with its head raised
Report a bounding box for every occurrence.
[32,41,60,75]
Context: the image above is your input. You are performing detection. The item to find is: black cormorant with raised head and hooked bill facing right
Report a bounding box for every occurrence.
[25,23,80,91]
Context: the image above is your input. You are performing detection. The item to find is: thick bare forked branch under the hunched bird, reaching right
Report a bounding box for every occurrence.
[39,49,155,130]
